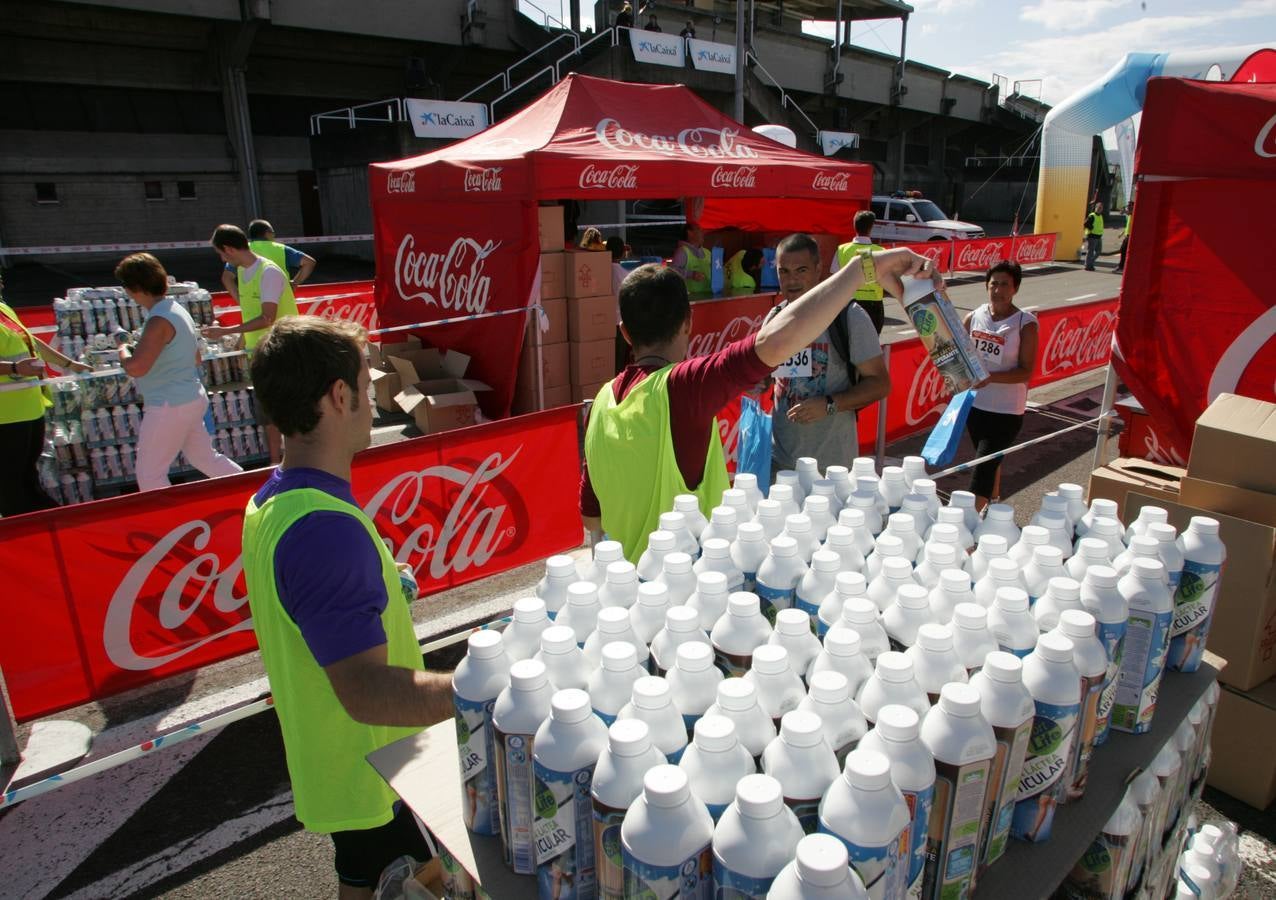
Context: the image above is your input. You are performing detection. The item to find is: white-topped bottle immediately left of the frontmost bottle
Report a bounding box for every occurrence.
[713,775,803,900]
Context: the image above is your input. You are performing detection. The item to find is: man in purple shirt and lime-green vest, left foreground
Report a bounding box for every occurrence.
[242,315,452,899]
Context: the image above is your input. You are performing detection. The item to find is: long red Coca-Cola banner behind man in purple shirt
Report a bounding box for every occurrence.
[0,406,581,720]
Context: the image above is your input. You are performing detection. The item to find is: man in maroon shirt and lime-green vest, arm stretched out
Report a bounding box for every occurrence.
[581,249,942,562]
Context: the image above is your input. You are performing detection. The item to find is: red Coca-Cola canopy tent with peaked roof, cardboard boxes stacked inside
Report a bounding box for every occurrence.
[369,75,873,416]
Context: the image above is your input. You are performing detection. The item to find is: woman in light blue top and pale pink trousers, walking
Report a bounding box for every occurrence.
[115,253,244,490]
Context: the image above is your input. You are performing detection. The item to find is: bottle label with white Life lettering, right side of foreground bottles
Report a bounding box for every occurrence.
[1011,701,1081,841]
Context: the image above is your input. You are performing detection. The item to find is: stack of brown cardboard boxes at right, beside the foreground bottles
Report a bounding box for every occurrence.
[1090,393,1276,809]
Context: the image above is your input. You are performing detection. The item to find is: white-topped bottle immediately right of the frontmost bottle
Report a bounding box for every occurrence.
[819,742,925,900]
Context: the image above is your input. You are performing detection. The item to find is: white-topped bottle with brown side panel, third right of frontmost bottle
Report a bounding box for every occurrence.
[921,684,997,900]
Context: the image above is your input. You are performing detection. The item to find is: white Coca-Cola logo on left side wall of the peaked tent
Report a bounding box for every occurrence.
[394,234,500,314]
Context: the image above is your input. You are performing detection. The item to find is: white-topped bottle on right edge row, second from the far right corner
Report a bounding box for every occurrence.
[1111,559,1174,734]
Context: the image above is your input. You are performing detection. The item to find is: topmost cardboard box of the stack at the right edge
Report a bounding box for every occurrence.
[1188,393,1276,494]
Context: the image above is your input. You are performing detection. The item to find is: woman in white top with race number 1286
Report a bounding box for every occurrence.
[966,259,1037,509]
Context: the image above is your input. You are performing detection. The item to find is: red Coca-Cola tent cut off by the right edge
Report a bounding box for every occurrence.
[1114,78,1276,460]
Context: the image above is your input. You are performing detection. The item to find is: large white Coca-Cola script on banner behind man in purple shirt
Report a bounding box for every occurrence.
[102,446,523,671]
